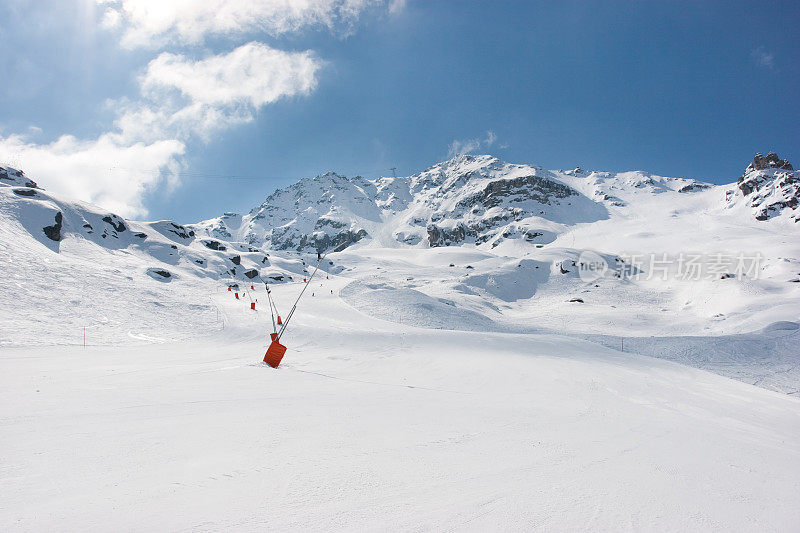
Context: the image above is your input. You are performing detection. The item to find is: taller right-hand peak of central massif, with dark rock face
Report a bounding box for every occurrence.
[395,155,605,248]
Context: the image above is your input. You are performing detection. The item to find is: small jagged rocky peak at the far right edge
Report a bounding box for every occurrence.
[727,152,800,222]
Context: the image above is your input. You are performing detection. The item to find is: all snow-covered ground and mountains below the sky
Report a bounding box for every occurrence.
[0,153,800,532]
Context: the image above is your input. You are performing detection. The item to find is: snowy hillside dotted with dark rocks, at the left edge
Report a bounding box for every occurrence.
[0,163,318,346]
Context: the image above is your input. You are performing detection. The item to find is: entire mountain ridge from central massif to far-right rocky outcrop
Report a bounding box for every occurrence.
[191,152,800,252]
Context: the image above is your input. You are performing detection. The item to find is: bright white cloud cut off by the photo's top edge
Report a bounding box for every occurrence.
[98,0,386,47]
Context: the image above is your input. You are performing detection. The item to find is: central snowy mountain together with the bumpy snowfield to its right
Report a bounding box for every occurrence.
[192,153,800,335]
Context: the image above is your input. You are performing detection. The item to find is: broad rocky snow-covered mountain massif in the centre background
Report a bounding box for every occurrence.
[193,154,606,251]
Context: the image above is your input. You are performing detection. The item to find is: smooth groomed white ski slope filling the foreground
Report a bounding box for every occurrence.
[0,276,800,532]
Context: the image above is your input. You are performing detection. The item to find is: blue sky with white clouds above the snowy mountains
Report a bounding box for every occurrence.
[0,0,800,222]
